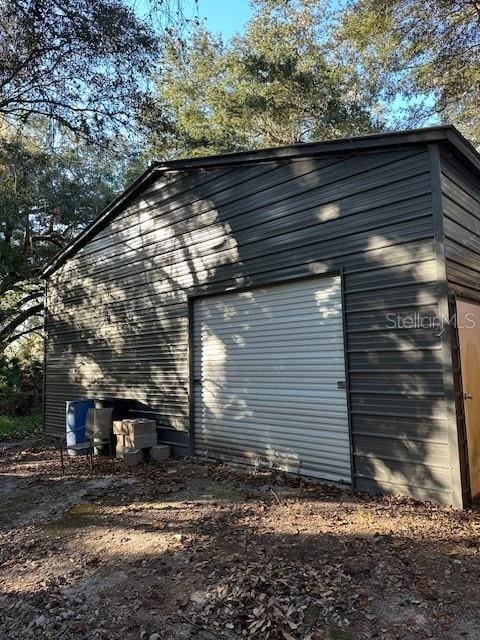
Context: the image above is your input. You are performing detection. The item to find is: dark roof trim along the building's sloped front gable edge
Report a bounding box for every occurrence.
[42,125,480,278]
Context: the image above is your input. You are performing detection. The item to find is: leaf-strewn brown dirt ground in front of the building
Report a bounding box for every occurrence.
[0,442,480,640]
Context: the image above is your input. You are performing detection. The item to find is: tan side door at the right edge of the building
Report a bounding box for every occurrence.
[457,300,480,498]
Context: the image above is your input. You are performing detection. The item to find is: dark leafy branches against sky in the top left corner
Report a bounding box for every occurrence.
[0,0,159,140]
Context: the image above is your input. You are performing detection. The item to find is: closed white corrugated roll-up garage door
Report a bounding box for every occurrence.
[193,277,350,482]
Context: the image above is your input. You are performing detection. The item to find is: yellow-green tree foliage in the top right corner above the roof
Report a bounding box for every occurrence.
[337,0,480,142]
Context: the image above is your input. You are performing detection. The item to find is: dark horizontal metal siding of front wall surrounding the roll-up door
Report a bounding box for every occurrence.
[46,147,451,503]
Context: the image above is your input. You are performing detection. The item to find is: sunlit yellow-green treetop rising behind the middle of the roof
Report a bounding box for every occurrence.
[143,0,379,158]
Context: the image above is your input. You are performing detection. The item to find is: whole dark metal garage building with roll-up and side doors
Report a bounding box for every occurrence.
[44,127,480,506]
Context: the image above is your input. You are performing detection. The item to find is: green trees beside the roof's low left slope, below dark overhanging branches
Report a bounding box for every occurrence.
[0,121,131,346]
